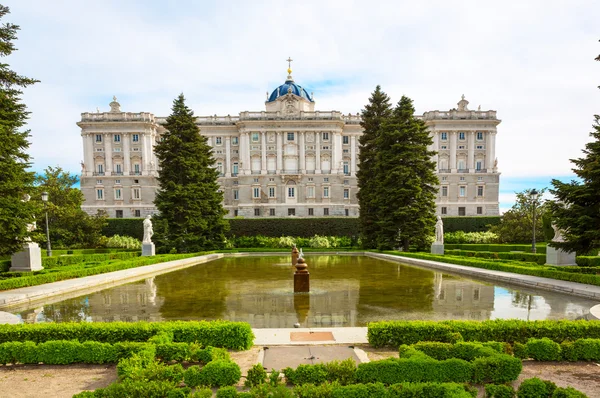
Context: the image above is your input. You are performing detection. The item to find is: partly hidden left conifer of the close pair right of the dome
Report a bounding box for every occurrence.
[356,85,392,249]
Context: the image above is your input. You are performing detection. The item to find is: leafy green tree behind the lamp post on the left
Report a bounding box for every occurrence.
[31,167,107,248]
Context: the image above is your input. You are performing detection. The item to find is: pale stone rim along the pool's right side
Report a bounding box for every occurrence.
[365,252,600,301]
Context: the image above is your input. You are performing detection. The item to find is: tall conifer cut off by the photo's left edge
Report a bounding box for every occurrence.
[0,5,37,256]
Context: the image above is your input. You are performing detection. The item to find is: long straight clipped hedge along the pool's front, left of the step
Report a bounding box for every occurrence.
[0,321,254,350]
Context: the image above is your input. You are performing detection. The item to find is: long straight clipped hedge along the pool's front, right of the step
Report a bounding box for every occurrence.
[367,319,600,347]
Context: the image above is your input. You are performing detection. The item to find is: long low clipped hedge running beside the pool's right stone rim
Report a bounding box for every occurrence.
[392,251,600,286]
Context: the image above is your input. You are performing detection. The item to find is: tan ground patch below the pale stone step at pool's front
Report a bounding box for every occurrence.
[262,346,361,371]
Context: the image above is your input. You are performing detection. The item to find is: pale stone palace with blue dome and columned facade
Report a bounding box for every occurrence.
[77,69,500,218]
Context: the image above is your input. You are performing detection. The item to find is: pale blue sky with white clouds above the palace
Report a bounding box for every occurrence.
[2,0,600,213]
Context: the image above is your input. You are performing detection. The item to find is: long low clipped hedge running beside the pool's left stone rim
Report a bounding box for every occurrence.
[0,252,200,290]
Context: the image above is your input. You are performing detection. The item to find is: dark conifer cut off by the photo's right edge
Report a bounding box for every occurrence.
[548,45,600,254]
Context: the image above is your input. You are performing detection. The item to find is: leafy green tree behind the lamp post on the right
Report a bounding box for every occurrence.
[490,188,548,243]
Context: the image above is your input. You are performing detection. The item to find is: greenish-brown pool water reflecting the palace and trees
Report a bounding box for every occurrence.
[20,256,597,328]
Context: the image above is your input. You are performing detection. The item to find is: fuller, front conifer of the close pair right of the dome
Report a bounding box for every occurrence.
[373,96,439,250]
